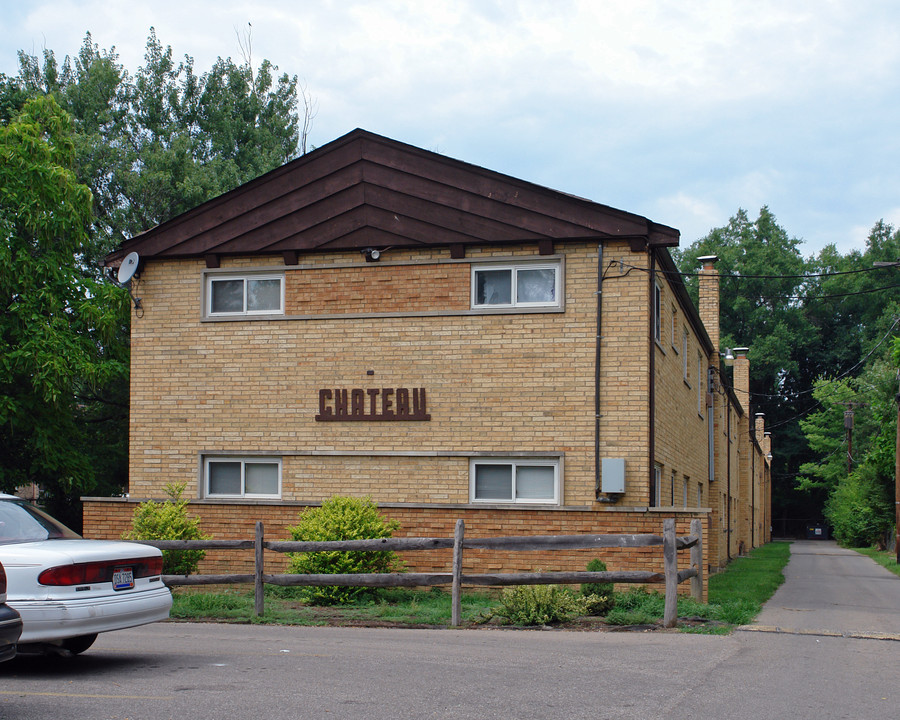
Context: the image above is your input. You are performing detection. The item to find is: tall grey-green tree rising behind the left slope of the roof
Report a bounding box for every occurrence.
[18,28,312,256]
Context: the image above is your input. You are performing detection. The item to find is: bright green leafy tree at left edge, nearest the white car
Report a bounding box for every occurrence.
[0,97,128,527]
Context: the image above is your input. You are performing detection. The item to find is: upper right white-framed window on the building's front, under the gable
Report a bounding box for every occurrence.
[472,263,560,308]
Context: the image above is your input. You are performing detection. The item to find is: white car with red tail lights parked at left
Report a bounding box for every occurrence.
[0,494,172,654]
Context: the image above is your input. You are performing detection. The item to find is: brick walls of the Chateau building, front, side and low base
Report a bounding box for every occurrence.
[84,245,767,592]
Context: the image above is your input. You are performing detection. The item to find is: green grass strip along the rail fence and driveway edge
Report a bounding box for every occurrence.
[165,542,792,634]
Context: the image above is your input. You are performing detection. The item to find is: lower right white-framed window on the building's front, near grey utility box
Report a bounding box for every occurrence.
[469,458,560,504]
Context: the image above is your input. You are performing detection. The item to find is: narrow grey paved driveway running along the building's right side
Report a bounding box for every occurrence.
[748,540,900,640]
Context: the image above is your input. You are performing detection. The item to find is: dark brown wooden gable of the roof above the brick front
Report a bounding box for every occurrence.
[107,130,678,264]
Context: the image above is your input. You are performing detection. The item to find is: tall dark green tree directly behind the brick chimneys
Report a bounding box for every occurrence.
[676,207,816,517]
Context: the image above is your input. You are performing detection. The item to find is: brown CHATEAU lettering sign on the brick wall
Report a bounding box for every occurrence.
[316,388,431,422]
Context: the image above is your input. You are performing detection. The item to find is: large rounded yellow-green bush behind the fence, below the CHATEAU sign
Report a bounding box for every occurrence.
[288,495,401,605]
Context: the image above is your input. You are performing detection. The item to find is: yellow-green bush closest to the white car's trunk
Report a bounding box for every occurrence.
[123,483,209,575]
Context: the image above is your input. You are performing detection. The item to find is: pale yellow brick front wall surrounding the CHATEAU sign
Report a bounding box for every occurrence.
[130,245,647,505]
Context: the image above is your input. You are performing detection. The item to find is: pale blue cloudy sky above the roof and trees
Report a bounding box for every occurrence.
[0,0,900,256]
